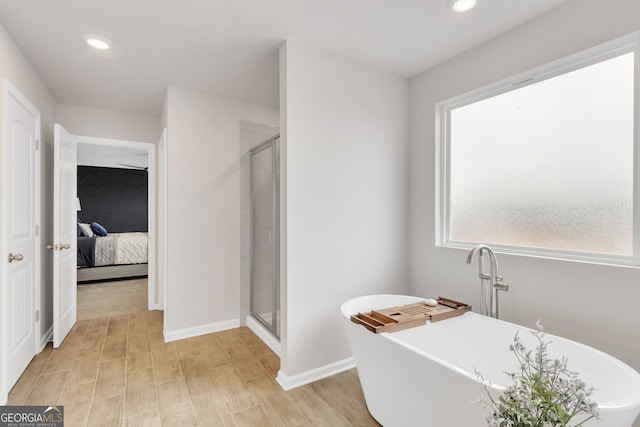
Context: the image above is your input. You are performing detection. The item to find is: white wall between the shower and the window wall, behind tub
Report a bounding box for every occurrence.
[278,42,408,387]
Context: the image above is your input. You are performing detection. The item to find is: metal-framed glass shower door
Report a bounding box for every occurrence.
[250,135,280,339]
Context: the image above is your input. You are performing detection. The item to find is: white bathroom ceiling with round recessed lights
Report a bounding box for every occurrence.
[0,0,566,115]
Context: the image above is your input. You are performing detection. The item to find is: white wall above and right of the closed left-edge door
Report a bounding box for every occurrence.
[0,25,56,362]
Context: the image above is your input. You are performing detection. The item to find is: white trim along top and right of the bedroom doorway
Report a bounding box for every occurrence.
[74,135,164,310]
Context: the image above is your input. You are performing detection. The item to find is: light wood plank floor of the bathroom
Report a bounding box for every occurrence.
[8,285,379,427]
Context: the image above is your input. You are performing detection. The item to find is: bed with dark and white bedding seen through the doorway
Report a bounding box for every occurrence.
[78,232,149,282]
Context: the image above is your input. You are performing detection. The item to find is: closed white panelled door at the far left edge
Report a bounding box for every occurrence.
[0,81,41,391]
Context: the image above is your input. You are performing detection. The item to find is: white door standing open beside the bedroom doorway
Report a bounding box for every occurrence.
[49,123,78,348]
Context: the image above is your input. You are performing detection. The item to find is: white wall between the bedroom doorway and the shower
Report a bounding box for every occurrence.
[163,87,279,339]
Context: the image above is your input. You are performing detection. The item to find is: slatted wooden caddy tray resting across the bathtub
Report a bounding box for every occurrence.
[351,297,471,334]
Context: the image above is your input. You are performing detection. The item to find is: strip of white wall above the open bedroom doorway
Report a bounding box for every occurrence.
[56,104,162,144]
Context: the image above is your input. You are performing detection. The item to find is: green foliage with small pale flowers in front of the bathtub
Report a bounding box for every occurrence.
[476,322,598,427]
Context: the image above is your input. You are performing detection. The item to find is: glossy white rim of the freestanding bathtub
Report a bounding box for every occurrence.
[340,294,640,410]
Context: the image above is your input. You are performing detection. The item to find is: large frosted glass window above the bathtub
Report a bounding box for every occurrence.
[441,36,637,264]
